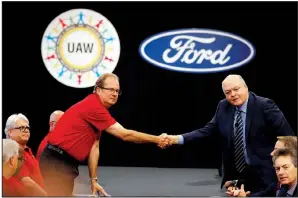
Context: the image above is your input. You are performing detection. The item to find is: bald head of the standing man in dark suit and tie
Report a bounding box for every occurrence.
[222,74,248,107]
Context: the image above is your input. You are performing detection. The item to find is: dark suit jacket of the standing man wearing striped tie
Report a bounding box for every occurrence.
[182,92,294,193]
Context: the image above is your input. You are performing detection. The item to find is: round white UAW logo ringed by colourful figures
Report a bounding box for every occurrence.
[41,9,120,88]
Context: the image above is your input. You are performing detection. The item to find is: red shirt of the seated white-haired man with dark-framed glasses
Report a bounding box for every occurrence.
[16,146,44,188]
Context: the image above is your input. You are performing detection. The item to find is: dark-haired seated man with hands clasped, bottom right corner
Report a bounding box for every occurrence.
[233,148,297,197]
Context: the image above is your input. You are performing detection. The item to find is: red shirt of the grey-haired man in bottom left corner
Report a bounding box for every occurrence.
[2,176,29,197]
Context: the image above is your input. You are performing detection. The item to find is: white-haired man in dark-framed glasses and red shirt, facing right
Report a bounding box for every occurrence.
[4,114,47,196]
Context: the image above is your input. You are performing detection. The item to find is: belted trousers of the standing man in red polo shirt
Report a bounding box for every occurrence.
[39,144,79,196]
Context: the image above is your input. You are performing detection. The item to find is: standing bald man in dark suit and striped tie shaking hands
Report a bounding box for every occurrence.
[162,75,294,192]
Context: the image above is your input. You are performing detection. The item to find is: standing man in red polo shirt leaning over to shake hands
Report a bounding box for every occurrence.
[40,73,167,196]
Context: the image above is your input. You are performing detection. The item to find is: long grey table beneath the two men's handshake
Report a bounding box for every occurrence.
[74,166,225,197]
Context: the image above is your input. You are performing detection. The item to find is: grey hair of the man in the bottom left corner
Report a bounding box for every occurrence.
[2,139,20,164]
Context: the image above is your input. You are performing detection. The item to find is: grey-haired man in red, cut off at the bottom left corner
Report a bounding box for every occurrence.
[2,139,27,197]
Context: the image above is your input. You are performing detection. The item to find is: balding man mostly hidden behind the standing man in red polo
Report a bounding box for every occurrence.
[36,110,64,161]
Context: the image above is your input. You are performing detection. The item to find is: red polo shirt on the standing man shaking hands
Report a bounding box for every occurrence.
[48,93,116,161]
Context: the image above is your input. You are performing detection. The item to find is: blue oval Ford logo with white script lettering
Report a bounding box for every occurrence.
[139,29,255,73]
